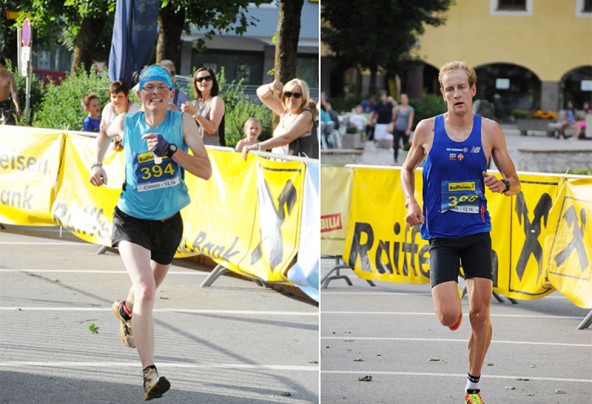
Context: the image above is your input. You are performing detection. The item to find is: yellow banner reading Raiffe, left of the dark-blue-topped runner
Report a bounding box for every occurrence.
[343,167,430,283]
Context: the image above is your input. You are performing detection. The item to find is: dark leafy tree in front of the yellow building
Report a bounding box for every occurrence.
[321,0,453,93]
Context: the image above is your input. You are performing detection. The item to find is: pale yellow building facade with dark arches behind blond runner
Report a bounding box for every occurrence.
[408,0,592,118]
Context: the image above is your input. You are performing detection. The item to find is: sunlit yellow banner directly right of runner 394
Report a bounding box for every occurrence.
[181,150,302,283]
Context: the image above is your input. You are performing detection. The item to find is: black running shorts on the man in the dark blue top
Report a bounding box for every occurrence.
[430,233,493,287]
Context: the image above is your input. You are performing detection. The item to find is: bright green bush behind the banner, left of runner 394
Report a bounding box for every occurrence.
[33,68,110,130]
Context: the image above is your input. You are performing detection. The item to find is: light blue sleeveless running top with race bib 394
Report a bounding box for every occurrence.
[117,111,190,220]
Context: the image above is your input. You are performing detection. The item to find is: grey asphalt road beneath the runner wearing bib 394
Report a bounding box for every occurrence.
[0,226,319,404]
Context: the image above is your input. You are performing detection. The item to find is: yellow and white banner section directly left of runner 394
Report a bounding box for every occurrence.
[51,134,125,246]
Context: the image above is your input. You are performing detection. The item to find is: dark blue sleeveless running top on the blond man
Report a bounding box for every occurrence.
[421,115,491,240]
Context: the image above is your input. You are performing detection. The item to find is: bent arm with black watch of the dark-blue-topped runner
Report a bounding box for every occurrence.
[483,119,520,196]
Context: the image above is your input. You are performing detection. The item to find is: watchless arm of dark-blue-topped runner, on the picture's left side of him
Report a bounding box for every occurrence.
[401,118,434,226]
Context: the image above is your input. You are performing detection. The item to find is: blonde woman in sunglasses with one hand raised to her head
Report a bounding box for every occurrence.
[243,79,319,159]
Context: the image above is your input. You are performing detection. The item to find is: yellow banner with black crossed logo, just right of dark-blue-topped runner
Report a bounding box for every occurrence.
[494,173,559,300]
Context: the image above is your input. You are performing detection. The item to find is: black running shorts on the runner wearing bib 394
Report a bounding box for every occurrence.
[111,207,183,265]
